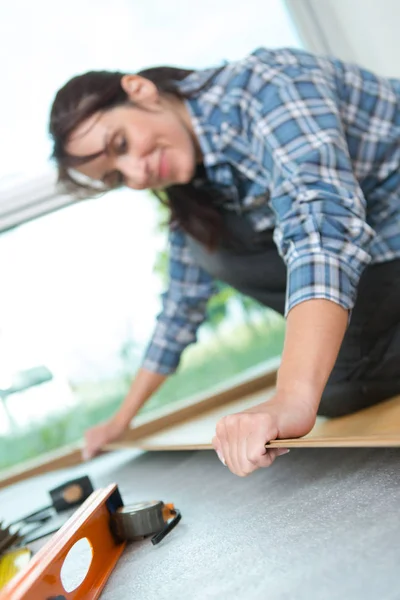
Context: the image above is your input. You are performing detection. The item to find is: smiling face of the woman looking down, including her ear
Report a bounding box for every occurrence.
[66,75,201,190]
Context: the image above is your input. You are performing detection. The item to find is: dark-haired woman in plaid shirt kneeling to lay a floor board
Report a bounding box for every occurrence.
[50,48,400,476]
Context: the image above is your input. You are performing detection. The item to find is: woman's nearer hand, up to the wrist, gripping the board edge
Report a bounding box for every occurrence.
[213,394,316,477]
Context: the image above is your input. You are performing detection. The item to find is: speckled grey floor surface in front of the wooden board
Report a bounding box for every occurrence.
[0,449,400,600]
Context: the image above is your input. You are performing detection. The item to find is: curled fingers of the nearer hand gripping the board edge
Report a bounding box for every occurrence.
[213,413,288,477]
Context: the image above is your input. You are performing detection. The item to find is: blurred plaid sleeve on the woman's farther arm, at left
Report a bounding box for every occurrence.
[142,229,215,375]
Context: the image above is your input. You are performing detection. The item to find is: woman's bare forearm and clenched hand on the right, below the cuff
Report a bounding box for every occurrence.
[213,299,348,477]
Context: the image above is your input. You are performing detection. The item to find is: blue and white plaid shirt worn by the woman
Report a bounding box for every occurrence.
[143,48,400,374]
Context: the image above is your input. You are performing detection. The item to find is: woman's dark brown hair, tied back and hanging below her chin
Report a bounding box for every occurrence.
[49,67,222,249]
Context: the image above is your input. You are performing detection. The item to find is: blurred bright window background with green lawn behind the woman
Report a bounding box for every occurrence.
[0,0,400,469]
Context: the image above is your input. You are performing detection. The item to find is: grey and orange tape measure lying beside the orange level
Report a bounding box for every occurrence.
[111,500,181,545]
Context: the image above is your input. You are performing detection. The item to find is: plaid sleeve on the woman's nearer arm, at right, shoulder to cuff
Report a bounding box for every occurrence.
[251,72,374,314]
